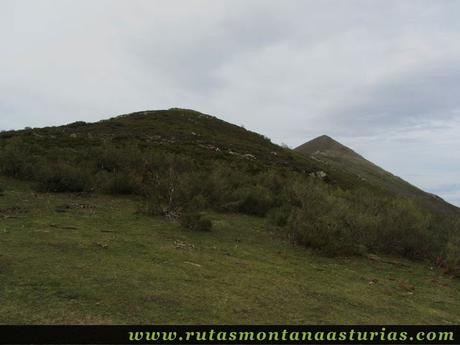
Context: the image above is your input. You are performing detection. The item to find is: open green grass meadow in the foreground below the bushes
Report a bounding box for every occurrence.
[0,178,460,324]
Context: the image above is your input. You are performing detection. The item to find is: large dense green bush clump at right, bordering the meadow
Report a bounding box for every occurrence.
[288,176,440,258]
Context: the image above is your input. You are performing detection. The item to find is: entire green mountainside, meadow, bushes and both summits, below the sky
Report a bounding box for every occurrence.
[0,108,460,323]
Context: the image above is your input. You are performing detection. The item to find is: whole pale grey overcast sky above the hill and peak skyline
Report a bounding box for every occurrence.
[0,0,460,205]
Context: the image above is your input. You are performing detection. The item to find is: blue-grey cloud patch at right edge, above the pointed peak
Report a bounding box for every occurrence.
[330,65,460,134]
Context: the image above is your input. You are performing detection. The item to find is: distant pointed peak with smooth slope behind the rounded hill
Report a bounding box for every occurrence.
[295,135,458,214]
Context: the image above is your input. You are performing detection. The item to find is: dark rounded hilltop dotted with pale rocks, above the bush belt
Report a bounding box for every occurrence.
[0,108,306,167]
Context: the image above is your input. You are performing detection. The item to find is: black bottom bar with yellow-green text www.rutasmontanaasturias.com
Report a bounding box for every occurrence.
[0,325,460,345]
